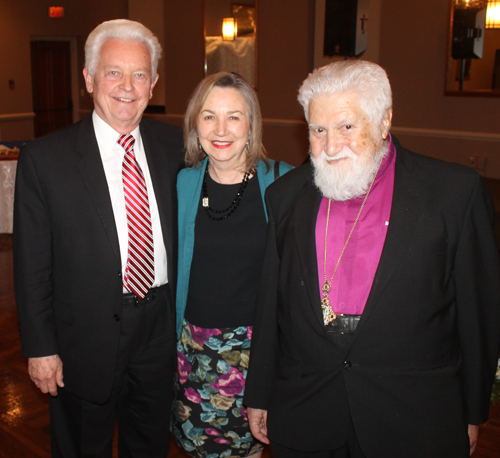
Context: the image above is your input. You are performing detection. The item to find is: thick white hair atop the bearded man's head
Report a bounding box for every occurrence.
[298,60,392,125]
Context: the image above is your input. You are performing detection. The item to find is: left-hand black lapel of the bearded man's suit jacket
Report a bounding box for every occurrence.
[294,175,323,327]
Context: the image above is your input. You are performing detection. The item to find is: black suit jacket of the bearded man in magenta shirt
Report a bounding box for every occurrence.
[245,141,500,458]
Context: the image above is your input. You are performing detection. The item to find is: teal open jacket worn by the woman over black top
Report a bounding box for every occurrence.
[176,159,293,337]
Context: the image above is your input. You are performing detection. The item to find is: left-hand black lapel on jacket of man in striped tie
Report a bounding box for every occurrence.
[76,115,121,265]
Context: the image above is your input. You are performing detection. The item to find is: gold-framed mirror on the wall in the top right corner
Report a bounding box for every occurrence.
[445,0,500,97]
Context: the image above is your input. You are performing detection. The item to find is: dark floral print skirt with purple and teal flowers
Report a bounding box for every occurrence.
[172,320,263,458]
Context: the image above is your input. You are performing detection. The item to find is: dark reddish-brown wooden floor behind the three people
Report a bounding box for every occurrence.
[0,247,500,458]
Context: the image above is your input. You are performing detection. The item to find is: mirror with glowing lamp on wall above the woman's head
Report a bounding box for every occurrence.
[204,0,257,87]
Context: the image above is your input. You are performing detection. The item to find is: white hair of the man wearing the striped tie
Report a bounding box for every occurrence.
[85,19,161,79]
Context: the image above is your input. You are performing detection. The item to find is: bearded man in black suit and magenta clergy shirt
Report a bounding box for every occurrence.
[244,61,500,458]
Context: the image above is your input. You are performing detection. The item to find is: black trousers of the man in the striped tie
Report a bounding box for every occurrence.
[49,286,176,458]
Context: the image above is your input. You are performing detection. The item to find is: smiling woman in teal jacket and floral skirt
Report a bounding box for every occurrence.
[172,72,291,458]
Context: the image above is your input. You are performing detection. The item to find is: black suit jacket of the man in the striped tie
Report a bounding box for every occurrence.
[14,116,183,403]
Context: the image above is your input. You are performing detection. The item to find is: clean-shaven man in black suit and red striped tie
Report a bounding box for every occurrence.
[14,20,183,458]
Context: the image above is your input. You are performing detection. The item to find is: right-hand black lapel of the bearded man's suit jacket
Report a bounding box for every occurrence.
[356,148,423,334]
